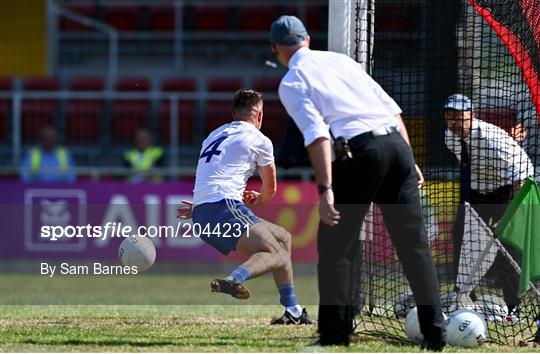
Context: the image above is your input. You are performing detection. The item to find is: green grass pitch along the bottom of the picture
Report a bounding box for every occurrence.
[0,274,538,352]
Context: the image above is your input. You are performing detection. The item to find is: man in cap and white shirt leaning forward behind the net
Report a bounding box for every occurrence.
[444,94,534,315]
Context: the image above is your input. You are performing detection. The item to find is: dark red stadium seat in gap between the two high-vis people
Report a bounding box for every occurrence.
[66,77,105,143]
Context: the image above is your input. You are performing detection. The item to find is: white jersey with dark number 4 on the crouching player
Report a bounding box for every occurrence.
[193,121,274,205]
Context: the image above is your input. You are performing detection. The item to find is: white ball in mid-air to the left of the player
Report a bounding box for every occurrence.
[118,236,156,272]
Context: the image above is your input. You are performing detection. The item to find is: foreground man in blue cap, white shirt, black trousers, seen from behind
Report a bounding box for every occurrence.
[271,16,445,350]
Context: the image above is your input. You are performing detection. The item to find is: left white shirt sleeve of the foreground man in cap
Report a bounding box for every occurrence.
[279,74,330,146]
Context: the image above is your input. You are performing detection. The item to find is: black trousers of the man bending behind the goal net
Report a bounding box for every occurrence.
[453,185,521,312]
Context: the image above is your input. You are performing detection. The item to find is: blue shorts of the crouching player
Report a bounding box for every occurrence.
[192,199,261,255]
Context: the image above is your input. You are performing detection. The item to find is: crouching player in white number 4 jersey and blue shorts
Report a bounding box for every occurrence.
[182,90,315,324]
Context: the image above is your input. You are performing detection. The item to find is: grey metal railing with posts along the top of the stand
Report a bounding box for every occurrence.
[47,0,328,78]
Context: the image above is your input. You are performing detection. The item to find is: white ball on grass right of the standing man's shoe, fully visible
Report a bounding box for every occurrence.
[446,309,488,347]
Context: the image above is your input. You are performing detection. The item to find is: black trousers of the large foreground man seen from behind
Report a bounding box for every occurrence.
[317,133,445,345]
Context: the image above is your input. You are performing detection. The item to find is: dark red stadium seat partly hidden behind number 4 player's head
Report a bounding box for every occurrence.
[204,77,243,134]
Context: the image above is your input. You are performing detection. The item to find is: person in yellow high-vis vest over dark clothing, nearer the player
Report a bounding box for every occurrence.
[123,128,164,182]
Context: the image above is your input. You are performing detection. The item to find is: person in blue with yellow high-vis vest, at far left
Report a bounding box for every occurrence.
[21,126,77,182]
